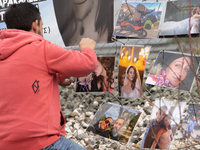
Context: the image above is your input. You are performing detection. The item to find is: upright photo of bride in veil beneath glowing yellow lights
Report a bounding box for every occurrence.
[118,45,151,98]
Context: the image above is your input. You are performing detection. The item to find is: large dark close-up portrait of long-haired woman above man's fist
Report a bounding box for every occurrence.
[53,0,114,46]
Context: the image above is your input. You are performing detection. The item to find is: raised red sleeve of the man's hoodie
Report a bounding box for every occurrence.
[44,42,97,81]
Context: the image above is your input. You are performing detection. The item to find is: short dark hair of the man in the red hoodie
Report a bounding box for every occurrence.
[5,3,41,31]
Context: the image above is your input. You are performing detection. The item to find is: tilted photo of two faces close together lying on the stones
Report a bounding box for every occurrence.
[86,103,141,144]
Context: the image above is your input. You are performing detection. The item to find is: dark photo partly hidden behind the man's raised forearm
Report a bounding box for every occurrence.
[76,57,115,92]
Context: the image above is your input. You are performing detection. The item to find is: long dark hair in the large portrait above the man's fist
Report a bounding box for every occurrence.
[53,0,114,46]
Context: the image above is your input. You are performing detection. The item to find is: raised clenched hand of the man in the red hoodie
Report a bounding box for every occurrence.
[79,38,96,51]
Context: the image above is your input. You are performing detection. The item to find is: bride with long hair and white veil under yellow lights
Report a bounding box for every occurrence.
[121,65,142,98]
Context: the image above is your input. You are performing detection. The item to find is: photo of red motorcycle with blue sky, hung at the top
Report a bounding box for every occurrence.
[113,1,163,38]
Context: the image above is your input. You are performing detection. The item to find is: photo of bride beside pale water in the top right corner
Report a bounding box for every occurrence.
[159,0,200,37]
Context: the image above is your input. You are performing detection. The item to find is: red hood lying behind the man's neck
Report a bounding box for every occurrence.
[0,29,44,61]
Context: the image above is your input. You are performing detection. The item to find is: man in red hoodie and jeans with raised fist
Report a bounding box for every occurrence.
[0,3,97,150]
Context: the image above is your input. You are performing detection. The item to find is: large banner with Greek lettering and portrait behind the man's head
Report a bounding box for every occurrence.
[0,0,113,47]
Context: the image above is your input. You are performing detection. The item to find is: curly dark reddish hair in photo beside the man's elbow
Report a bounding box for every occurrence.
[97,57,115,91]
